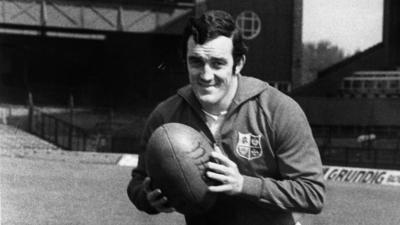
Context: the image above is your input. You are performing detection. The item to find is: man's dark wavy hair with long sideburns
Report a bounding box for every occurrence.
[182,10,248,67]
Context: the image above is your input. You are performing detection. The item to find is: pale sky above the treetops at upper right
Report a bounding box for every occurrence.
[303,0,383,54]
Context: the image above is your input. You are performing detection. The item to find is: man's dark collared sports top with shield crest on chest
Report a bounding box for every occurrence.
[128,75,325,225]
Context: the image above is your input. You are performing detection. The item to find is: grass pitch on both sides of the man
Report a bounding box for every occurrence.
[0,155,400,225]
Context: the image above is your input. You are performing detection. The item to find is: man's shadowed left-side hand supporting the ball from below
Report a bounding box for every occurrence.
[143,177,175,213]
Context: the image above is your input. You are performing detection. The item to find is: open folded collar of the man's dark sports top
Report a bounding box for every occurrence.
[178,75,268,114]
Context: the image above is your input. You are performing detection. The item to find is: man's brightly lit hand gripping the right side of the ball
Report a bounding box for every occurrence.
[207,149,244,195]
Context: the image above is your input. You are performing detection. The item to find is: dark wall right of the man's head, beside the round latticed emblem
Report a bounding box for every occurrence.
[203,0,302,81]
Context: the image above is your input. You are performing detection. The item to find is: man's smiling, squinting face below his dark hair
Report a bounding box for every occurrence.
[186,36,241,109]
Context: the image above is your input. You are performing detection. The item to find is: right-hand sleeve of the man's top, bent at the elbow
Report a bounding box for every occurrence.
[242,98,325,214]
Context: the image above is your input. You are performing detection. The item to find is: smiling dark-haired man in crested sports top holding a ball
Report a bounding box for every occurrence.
[128,11,325,225]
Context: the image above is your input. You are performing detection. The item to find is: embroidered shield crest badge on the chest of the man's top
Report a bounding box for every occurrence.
[236,132,263,160]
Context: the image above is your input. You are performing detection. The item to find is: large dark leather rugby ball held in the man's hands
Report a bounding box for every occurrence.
[146,123,216,215]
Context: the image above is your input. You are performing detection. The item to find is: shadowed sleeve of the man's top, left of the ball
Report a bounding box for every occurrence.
[127,110,162,214]
